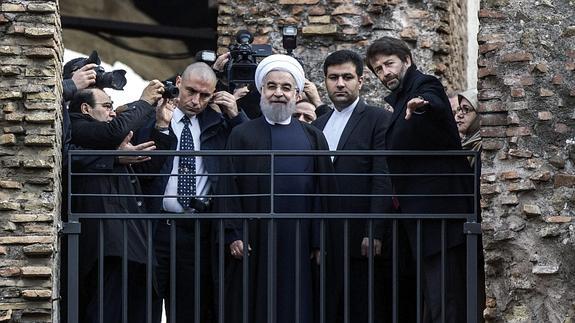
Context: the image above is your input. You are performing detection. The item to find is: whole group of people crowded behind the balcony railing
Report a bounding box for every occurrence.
[64,37,483,323]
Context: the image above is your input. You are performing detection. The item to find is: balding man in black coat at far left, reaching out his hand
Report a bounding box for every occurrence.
[70,80,174,322]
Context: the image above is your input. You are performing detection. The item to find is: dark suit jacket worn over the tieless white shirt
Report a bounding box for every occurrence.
[313,99,392,257]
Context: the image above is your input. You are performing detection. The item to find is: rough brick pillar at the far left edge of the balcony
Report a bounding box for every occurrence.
[0,0,63,322]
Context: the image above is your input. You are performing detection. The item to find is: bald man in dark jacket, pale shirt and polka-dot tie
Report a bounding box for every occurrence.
[137,63,248,322]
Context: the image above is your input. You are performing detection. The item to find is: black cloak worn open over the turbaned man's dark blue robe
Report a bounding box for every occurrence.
[219,117,337,322]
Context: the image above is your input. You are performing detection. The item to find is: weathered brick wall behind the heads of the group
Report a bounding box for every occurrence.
[218,0,467,109]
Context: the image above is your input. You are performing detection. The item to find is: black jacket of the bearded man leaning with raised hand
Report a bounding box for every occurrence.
[385,65,473,255]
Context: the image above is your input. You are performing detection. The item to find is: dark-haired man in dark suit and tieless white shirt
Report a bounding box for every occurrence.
[313,50,391,322]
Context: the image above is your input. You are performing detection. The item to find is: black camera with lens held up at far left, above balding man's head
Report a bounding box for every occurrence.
[64,51,128,90]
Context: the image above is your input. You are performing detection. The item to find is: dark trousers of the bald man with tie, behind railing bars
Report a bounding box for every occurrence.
[153,220,214,323]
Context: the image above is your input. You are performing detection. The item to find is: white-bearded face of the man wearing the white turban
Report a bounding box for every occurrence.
[260,71,299,122]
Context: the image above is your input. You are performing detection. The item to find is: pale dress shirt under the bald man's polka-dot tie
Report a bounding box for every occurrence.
[162,108,211,213]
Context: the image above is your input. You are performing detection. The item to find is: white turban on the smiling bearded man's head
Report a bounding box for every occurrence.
[255,54,305,93]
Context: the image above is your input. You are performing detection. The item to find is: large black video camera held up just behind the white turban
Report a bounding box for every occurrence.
[227,30,272,90]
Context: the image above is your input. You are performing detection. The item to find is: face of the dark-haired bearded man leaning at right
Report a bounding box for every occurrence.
[370,55,411,91]
